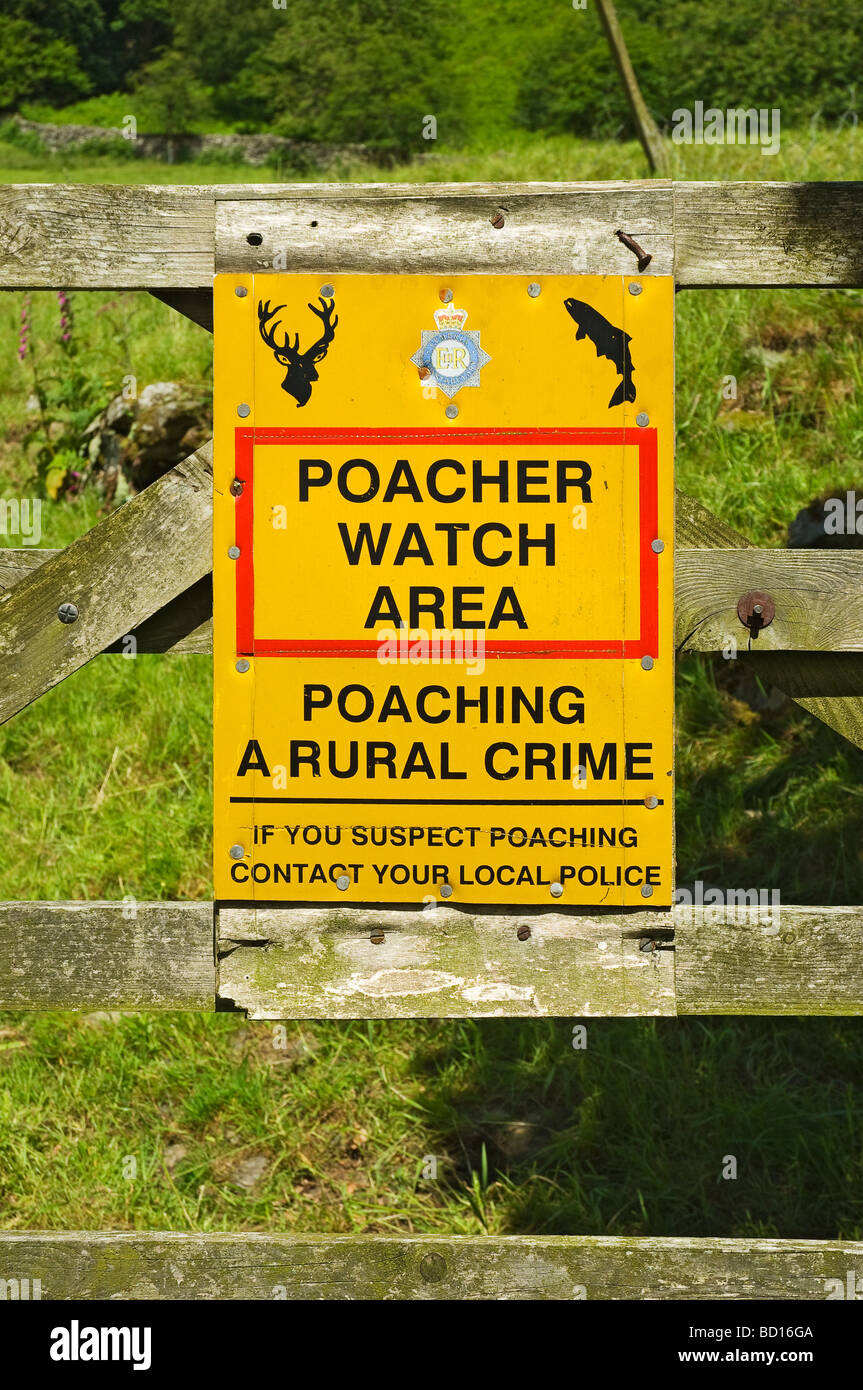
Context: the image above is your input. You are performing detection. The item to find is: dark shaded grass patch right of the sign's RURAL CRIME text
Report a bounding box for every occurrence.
[675,657,863,906]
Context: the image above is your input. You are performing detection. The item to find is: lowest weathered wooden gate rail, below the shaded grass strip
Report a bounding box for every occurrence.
[0,1232,863,1302]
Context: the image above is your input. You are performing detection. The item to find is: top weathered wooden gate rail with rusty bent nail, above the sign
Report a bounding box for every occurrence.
[0,179,863,286]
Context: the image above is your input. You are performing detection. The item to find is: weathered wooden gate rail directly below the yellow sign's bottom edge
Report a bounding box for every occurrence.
[0,902,863,1019]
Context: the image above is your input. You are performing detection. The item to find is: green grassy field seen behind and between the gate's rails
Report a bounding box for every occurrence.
[0,129,863,1237]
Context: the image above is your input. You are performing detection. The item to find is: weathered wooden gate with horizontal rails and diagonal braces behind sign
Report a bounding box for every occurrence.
[0,181,863,1298]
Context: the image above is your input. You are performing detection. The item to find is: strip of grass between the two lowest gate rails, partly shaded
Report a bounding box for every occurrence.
[0,1015,863,1240]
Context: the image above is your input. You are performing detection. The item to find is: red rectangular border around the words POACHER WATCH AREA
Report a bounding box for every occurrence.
[235,427,659,660]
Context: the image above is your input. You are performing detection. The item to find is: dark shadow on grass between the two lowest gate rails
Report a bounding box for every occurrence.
[414,1017,863,1238]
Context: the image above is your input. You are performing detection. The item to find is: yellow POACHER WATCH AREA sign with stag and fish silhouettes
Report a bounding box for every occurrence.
[213,274,674,908]
